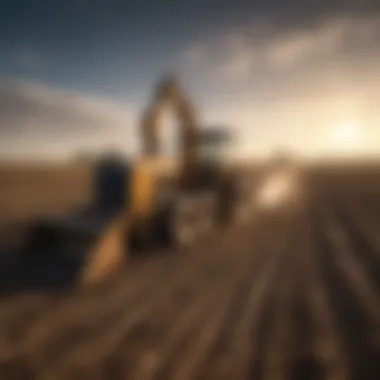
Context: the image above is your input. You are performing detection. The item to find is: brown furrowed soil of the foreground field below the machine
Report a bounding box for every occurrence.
[0,168,380,380]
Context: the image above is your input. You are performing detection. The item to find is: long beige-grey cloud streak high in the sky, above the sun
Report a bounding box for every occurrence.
[181,15,380,81]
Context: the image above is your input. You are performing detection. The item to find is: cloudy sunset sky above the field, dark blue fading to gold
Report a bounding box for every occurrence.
[0,0,380,159]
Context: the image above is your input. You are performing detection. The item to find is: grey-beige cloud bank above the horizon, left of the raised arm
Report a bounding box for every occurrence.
[0,79,136,156]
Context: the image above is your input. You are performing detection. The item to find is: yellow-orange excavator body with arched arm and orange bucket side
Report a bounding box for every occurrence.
[26,78,246,285]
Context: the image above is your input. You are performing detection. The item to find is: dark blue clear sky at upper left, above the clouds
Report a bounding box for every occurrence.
[0,0,246,97]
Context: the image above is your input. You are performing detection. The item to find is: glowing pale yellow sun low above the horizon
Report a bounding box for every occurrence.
[331,122,364,152]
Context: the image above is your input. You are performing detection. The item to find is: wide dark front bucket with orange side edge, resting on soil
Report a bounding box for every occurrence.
[27,213,128,287]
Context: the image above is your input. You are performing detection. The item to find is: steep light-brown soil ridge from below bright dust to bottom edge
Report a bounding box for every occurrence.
[196,214,292,380]
